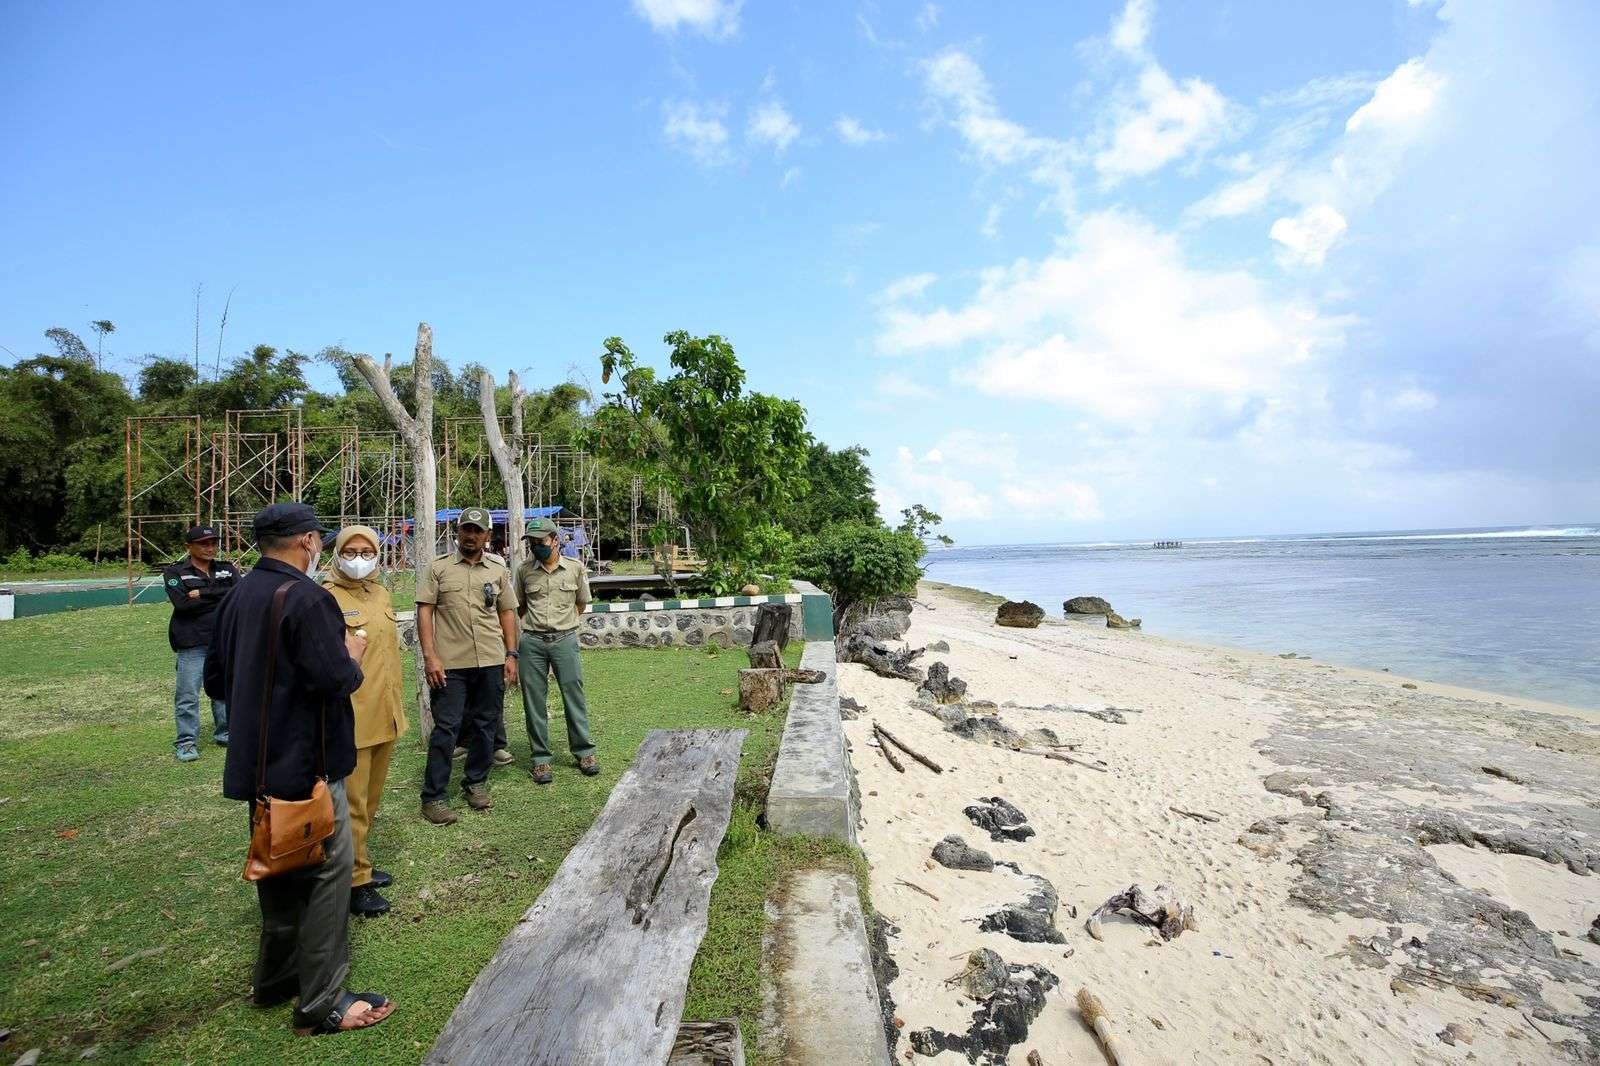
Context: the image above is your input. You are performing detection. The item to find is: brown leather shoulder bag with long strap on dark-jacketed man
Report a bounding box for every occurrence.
[243,581,333,880]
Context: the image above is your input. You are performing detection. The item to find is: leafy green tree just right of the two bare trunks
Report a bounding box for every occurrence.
[589,330,810,591]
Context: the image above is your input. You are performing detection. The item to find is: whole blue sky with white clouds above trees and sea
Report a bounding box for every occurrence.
[0,0,1600,543]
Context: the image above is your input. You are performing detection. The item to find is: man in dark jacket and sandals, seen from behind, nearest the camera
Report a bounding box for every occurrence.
[205,503,394,1032]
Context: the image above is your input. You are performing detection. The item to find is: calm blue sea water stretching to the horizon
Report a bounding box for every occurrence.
[923,523,1600,709]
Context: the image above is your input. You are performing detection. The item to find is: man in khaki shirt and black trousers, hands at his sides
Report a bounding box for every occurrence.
[416,507,517,826]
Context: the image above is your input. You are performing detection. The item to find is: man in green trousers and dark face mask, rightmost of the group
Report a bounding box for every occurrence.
[517,519,600,784]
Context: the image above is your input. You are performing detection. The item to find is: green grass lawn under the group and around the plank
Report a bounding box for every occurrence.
[0,605,825,1064]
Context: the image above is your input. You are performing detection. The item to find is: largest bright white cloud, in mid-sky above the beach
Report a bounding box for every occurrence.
[877,204,1342,426]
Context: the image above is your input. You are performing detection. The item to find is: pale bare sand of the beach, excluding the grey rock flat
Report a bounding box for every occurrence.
[840,586,1600,1064]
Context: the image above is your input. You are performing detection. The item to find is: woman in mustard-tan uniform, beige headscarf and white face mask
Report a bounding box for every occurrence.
[323,525,410,917]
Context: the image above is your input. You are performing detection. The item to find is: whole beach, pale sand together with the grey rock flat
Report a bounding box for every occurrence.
[840,584,1600,1066]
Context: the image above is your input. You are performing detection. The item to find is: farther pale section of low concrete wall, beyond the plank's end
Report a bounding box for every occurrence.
[766,640,856,844]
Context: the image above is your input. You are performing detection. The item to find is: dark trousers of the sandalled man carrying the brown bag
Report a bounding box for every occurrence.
[254,781,355,1026]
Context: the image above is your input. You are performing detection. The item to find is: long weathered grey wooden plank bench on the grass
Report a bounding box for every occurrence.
[426,730,746,1066]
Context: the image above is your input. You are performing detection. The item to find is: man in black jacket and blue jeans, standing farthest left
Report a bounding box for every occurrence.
[162,525,238,762]
